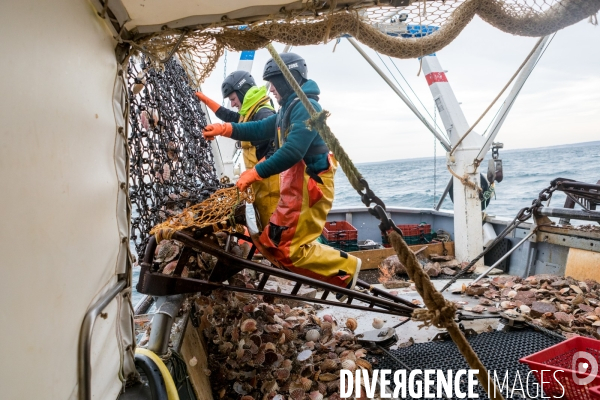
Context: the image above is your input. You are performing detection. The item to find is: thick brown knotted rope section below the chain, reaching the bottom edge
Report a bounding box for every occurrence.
[388,231,504,400]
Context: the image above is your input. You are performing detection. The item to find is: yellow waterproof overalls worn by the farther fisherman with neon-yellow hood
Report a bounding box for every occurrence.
[240,97,279,230]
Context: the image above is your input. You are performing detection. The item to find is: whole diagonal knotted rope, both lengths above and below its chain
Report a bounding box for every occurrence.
[267,44,504,400]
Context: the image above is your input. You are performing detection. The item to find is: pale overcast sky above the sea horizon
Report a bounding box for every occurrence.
[202,17,600,162]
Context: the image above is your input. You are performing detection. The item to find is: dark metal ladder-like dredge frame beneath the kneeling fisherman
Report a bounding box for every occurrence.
[136,214,418,317]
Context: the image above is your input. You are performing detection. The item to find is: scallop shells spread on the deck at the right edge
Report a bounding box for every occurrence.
[460,274,600,339]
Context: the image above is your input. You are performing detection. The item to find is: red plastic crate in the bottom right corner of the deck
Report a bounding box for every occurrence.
[519,336,600,400]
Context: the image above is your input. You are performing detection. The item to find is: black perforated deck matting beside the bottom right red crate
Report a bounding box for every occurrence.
[373,330,559,399]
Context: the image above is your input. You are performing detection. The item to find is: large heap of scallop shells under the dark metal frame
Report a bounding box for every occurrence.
[195,274,372,400]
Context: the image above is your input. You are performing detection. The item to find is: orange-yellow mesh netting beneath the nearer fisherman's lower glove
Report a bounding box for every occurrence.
[150,187,254,235]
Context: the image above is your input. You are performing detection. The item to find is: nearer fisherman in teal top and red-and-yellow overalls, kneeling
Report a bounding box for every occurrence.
[203,53,361,296]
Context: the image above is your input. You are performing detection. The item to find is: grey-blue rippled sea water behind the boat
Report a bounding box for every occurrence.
[132,141,600,304]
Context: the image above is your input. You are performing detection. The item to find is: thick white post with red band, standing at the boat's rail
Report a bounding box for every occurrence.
[423,54,484,265]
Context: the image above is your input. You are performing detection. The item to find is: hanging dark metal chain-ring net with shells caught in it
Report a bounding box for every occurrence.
[127,57,220,254]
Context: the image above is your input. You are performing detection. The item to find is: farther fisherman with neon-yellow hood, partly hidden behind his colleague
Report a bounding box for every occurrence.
[196,71,279,231]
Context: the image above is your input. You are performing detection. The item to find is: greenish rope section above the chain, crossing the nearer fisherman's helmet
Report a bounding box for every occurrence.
[267,43,364,191]
